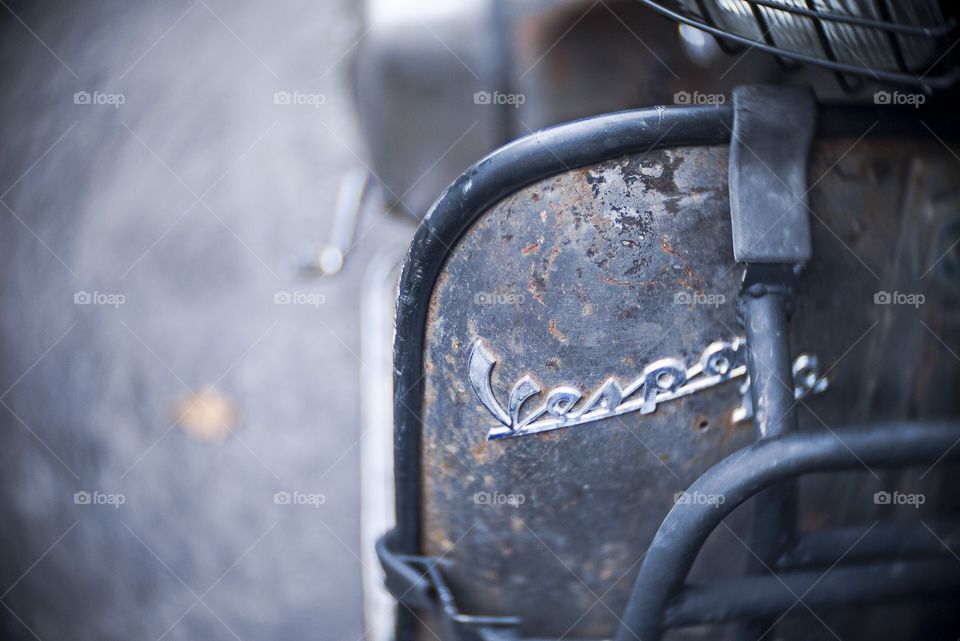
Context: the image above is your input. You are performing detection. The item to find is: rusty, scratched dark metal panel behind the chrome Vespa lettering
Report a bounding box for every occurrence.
[422,140,958,638]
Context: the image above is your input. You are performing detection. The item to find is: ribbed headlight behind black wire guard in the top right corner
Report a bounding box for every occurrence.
[640,0,960,91]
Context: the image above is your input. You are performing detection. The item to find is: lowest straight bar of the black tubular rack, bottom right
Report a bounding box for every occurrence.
[664,559,960,638]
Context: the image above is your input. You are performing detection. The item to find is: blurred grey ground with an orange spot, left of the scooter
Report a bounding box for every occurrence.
[0,0,413,641]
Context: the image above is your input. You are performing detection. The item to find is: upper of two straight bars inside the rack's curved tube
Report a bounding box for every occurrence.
[777,519,960,570]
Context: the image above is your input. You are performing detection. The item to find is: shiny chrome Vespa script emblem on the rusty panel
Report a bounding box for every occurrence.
[469,338,827,440]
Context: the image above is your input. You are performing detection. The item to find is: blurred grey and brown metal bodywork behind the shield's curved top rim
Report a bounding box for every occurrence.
[356,0,778,218]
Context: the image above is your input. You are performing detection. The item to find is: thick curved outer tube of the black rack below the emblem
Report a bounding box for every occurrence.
[614,421,960,641]
